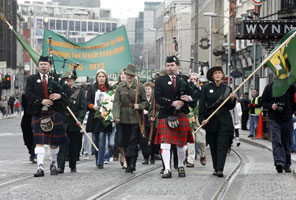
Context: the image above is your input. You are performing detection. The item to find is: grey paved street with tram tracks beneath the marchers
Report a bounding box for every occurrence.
[0,117,296,200]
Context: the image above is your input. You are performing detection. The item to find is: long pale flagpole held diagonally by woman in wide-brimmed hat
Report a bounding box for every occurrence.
[194,31,296,133]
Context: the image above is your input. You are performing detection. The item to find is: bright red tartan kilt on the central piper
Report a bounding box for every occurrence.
[154,113,194,146]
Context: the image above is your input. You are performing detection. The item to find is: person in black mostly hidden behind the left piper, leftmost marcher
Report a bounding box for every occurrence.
[21,94,37,163]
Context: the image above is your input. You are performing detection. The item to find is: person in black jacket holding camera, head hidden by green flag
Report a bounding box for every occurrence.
[261,83,295,173]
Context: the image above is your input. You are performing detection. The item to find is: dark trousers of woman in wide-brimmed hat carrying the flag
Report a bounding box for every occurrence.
[206,130,233,171]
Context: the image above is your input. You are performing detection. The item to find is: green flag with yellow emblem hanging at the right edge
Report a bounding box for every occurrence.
[266,29,296,97]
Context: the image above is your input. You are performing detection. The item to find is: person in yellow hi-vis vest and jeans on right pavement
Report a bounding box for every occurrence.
[248,89,262,137]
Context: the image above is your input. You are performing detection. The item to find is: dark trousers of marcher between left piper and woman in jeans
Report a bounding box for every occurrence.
[58,131,81,169]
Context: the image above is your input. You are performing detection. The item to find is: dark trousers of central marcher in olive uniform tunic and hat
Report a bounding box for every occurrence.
[120,124,141,164]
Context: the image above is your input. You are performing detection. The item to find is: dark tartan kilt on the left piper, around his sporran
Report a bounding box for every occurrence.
[32,111,69,146]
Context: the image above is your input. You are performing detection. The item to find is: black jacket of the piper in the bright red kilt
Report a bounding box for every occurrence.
[154,75,197,119]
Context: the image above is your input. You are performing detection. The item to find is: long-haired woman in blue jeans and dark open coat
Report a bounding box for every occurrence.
[86,70,112,169]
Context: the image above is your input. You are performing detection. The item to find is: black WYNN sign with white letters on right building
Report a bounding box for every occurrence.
[234,20,296,39]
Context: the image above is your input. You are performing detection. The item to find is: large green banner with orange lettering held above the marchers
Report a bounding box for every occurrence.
[42,26,134,79]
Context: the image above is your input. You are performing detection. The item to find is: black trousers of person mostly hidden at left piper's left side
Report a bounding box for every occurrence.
[21,114,36,156]
